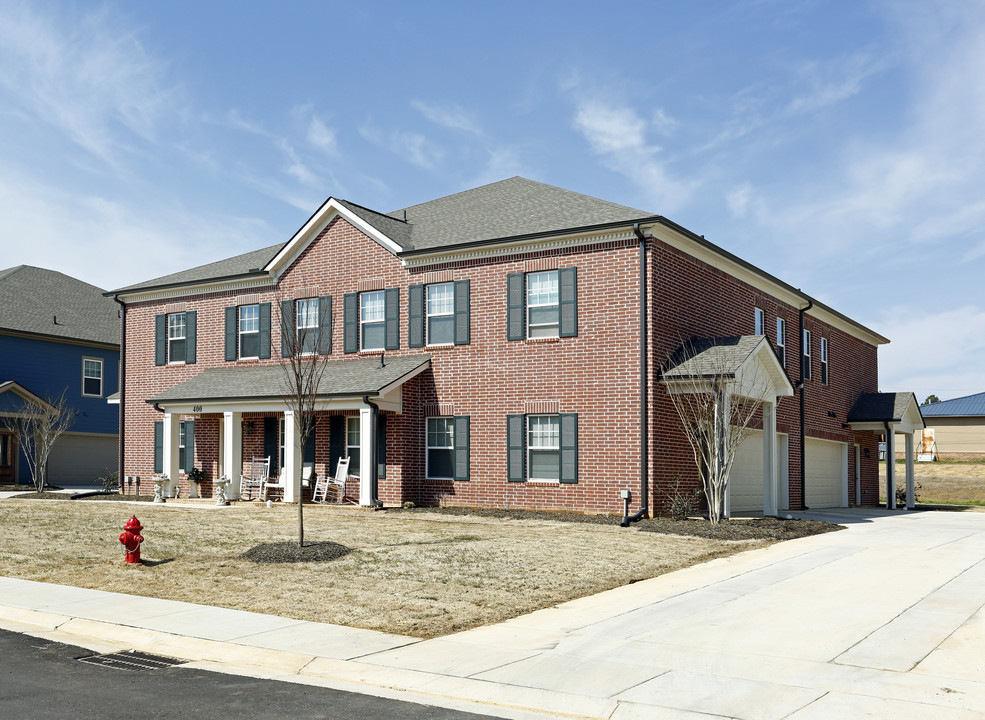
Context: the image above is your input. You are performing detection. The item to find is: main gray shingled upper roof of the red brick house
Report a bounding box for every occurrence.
[114,177,653,292]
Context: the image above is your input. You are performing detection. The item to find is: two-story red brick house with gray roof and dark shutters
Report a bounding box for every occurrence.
[110,178,924,513]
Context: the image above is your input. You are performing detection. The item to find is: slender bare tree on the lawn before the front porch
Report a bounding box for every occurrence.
[281,298,328,547]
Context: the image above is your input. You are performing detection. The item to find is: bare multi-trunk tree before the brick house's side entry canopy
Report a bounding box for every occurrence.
[662,336,772,523]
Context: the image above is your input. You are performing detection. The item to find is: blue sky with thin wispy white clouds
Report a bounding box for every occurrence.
[0,0,985,401]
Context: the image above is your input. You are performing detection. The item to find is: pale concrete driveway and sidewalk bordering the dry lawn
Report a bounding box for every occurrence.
[0,510,985,720]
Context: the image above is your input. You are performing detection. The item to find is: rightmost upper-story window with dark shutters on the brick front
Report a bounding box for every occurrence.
[506,268,578,340]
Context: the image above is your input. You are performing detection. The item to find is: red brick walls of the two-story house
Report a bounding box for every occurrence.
[123,202,878,514]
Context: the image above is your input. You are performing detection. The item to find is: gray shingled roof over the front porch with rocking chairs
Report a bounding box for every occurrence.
[147,355,431,404]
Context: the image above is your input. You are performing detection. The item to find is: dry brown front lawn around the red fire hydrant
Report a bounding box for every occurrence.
[0,499,767,637]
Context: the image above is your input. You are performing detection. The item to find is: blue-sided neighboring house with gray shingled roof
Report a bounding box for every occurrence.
[0,265,120,485]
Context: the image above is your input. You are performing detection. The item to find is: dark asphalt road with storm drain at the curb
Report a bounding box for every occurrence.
[0,630,496,720]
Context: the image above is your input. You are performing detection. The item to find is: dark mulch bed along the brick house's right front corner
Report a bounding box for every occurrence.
[396,507,844,540]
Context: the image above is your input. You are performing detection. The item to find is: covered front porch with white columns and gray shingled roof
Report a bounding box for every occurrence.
[147,355,430,500]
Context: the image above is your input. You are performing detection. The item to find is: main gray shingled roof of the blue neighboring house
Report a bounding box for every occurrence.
[0,265,120,345]
